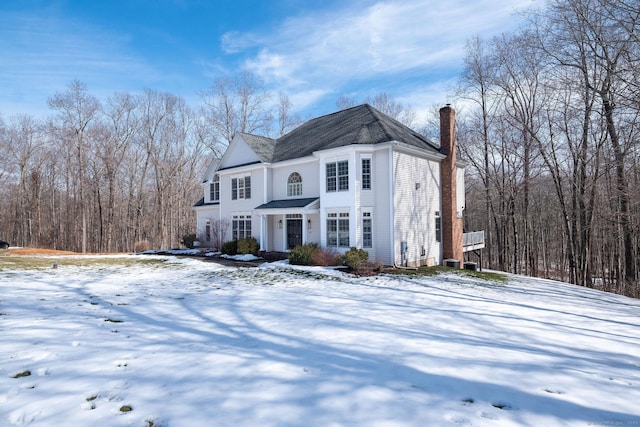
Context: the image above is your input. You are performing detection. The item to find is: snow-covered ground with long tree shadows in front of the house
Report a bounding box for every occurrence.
[0,256,640,427]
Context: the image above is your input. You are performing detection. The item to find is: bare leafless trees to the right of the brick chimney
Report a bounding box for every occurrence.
[459,0,640,297]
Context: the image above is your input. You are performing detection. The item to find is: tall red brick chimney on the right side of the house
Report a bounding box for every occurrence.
[440,104,464,266]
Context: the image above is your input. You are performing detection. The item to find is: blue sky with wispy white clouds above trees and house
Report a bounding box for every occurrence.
[0,0,541,118]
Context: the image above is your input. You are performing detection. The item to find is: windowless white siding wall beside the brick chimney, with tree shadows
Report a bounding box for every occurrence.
[393,151,440,266]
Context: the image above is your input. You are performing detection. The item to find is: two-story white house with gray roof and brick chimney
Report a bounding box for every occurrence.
[194,104,472,266]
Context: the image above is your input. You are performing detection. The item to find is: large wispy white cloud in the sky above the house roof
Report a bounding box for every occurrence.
[228,0,534,114]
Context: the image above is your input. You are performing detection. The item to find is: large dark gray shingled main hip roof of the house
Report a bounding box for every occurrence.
[272,104,439,162]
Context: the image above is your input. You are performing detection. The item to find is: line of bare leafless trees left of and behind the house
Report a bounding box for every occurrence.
[0,73,300,253]
